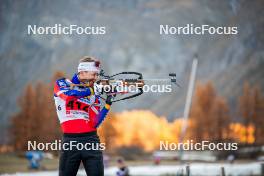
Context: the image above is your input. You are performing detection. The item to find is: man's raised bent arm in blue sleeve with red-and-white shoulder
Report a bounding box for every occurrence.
[54,79,94,100]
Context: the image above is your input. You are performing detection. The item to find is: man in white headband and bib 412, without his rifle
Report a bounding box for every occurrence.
[54,57,112,176]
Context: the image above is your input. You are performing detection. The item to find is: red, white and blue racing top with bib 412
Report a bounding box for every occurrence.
[54,74,110,133]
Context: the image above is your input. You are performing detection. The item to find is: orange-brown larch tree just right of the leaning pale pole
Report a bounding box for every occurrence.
[190,82,230,141]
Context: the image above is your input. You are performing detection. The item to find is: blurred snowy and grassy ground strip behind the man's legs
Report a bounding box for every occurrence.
[0,153,261,176]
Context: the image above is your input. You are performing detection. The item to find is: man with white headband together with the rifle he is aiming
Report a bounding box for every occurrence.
[54,57,177,176]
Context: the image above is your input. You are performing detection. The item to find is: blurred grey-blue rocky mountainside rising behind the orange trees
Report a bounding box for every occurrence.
[0,0,264,143]
